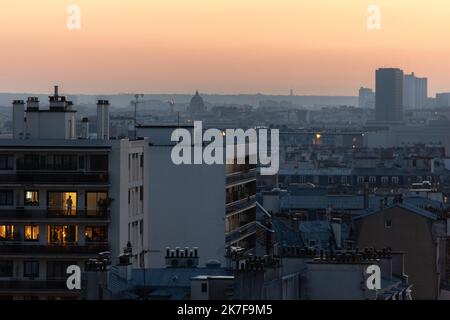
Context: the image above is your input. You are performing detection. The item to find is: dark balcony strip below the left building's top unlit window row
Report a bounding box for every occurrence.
[0,172,109,185]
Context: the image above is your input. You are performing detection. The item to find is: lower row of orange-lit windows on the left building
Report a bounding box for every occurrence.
[0,224,108,244]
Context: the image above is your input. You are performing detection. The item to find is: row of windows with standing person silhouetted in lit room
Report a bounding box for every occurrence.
[0,190,108,210]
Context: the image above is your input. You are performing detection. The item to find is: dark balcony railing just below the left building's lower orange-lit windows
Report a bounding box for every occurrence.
[0,241,109,254]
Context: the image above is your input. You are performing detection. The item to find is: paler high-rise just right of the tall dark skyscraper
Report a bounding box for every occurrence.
[403,72,428,109]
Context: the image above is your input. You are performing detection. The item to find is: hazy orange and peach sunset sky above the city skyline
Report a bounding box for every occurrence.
[0,0,450,95]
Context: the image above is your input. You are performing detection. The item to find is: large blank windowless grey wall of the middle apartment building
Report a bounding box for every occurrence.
[146,146,226,267]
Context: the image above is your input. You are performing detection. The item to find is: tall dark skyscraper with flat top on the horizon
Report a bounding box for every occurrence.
[375,68,403,122]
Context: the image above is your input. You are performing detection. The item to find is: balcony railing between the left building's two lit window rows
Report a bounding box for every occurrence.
[0,208,109,220]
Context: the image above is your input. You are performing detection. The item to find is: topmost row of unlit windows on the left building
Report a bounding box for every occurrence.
[0,154,108,172]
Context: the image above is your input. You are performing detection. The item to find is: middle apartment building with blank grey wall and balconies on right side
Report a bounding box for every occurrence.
[137,125,256,268]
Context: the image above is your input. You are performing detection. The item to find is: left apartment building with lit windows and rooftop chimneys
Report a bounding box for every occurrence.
[0,87,148,299]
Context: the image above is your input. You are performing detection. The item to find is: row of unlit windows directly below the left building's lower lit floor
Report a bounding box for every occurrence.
[0,260,77,280]
